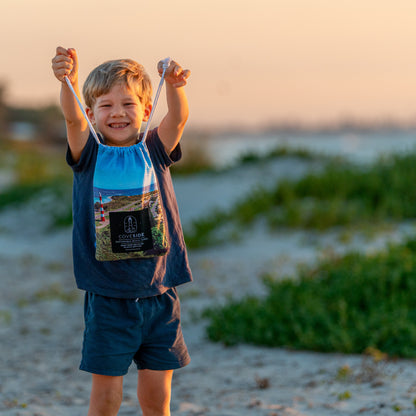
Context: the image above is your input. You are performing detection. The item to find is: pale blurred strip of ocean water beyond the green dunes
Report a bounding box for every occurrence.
[204,130,416,167]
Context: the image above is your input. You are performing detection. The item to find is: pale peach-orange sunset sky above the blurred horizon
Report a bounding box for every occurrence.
[0,0,416,128]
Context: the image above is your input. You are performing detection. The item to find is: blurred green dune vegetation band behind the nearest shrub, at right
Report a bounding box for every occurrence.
[186,153,416,249]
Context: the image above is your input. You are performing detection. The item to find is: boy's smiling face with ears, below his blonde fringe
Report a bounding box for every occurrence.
[86,84,152,146]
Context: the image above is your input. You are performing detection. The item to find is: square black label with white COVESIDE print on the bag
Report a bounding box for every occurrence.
[110,208,153,253]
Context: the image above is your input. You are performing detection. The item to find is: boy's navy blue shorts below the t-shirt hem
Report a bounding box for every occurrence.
[80,288,190,376]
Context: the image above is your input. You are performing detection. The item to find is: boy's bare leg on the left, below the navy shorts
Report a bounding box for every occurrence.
[88,374,123,416]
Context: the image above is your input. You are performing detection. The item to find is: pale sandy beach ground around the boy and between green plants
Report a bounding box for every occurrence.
[0,159,416,416]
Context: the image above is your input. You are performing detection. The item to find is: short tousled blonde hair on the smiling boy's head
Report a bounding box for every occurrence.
[82,59,152,108]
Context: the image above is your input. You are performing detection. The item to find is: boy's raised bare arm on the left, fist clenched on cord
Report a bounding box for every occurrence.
[52,46,89,162]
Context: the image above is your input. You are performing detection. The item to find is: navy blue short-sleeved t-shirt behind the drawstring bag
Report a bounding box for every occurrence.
[67,129,192,298]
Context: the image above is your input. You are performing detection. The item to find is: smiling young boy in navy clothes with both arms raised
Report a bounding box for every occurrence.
[52,47,192,416]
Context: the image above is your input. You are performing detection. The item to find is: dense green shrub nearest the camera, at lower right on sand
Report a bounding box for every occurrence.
[206,240,416,357]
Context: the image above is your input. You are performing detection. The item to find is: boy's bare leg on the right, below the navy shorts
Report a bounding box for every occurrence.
[137,370,173,416]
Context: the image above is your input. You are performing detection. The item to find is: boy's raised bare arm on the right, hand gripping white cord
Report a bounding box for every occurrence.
[158,61,191,154]
